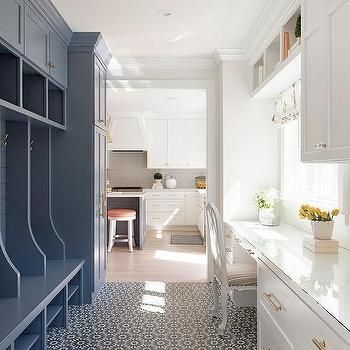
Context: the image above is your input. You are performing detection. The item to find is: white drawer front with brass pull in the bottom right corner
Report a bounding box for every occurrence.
[298,300,350,350]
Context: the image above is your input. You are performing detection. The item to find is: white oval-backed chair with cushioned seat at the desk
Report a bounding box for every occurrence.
[206,203,257,335]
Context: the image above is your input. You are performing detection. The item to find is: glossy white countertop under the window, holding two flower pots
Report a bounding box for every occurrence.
[225,221,350,330]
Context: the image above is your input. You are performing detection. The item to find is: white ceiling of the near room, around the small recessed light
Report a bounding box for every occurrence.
[52,0,269,57]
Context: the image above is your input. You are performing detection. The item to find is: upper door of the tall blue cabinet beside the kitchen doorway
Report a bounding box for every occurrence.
[95,58,107,130]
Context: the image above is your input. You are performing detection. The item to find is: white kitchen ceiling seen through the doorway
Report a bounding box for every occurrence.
[107,87,207,118]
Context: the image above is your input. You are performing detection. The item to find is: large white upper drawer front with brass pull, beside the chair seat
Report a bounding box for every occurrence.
[258,262,298,350]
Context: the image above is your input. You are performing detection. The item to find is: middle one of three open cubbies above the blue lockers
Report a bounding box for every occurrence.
[22,62,46,117]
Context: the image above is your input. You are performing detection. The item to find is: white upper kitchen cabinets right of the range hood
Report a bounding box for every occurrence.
[147,120,206,169]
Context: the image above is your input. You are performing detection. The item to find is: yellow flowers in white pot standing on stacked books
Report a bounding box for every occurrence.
[299,204,340,239]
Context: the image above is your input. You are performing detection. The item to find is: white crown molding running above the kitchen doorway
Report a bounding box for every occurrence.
[108,57,217,76]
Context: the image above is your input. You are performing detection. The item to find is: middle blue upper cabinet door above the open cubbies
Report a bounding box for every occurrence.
[25,6,49,73]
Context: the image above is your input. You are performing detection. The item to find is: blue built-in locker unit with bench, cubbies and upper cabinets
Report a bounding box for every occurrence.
[0,0,89,350]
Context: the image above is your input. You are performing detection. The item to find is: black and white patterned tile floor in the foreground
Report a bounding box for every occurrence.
[48,282,257,350]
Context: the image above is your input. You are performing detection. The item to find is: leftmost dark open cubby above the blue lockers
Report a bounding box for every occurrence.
[0,44,19,105]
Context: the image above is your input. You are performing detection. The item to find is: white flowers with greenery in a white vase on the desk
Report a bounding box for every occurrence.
[254,188,280,226]
